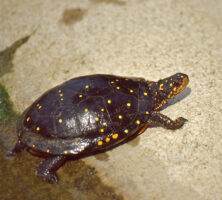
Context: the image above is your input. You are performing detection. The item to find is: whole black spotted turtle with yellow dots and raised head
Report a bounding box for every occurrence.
[12,73,189,183]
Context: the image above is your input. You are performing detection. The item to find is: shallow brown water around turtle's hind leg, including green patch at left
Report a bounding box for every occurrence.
[0,87,123,200]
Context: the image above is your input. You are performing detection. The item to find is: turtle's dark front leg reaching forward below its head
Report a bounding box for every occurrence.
[150,112,187,130]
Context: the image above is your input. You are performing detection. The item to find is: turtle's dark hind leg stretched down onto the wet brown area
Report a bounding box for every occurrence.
[37,156,66,183]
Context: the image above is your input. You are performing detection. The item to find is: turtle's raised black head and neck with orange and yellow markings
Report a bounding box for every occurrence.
[149,73,189,110]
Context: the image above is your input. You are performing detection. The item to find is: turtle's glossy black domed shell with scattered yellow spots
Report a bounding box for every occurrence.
[18,75,154,155]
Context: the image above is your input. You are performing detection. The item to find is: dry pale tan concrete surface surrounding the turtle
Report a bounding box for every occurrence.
[0,0,222,200]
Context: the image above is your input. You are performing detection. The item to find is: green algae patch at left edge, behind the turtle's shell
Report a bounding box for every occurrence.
[0,83,18,123]
